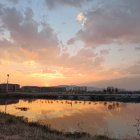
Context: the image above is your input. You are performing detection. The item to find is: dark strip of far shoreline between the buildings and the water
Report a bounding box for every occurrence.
[0,92,140,103]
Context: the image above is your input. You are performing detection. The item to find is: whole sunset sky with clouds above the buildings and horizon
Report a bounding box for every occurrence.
[0,0,140,89]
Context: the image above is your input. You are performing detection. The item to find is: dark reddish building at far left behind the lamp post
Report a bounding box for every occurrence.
[0,83,20,92]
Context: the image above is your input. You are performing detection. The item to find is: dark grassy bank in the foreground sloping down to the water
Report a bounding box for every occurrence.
[0,113,116,140]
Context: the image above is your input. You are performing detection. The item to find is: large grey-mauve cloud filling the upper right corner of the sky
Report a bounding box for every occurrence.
[70,0,140,47]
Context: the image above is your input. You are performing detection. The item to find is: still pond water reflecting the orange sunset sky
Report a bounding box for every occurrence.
[0,100,140,137]
